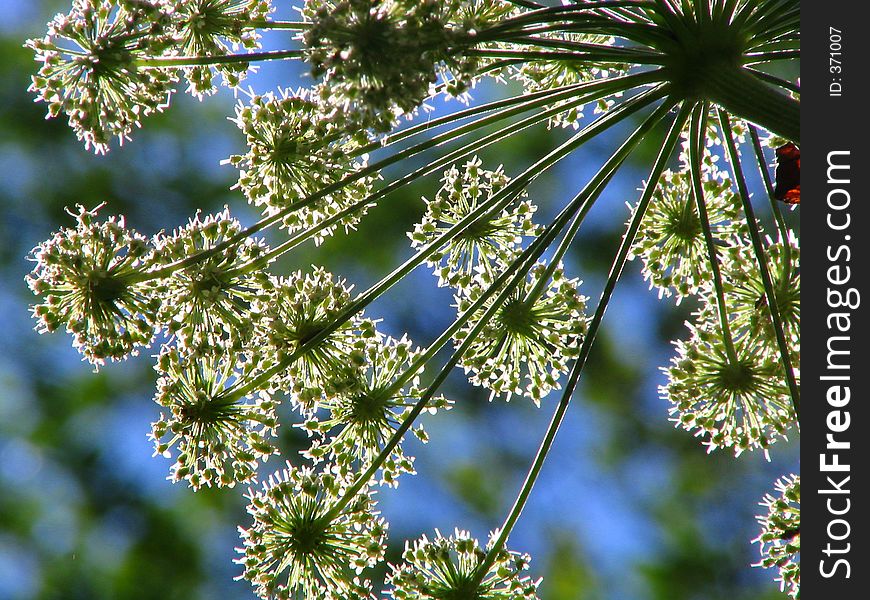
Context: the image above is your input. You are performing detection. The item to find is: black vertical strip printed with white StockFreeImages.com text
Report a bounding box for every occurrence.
[799,0,870,600]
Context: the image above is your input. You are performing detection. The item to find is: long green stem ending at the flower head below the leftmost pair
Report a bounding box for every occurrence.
[225,88,665,401]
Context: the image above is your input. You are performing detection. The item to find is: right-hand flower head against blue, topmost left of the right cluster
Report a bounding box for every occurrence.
[632,153,746,301]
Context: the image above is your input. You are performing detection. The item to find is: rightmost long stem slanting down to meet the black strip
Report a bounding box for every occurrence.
[719,109,801,420]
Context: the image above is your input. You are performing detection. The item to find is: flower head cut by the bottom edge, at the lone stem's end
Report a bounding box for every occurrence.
[388,529,541,600]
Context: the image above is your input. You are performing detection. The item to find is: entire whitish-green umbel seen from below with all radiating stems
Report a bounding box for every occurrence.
[27,0,800,600]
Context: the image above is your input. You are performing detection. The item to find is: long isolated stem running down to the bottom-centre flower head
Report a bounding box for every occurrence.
[472,103,691,589]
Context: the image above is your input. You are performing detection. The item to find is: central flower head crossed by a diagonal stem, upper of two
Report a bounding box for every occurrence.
[408,157,538,288]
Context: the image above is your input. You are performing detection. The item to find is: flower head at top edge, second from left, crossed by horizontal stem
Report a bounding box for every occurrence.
[165,0,272,95]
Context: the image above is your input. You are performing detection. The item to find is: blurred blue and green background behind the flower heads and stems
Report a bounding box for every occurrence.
[0,0,798,600]
